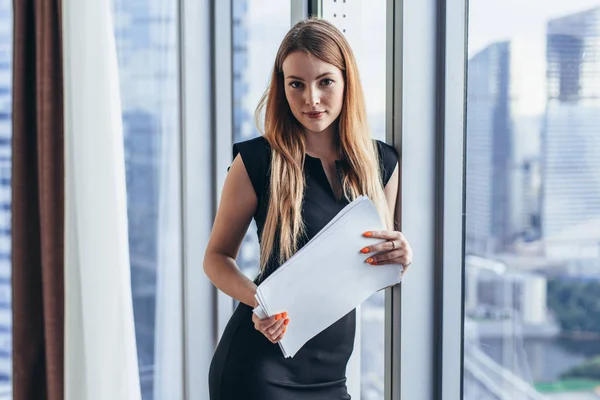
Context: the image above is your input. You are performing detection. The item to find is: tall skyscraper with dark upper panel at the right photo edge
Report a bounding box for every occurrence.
[541,7,600,260]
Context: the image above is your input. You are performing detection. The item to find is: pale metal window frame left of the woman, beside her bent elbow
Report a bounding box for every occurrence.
[178,0,224,399]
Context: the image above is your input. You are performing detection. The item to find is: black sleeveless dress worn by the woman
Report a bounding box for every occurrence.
[209,136,398,400]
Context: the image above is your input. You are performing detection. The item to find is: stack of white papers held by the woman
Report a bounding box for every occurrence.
[254,196,402,358]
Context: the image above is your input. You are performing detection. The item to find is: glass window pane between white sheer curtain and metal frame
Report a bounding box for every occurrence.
[113,0,183,400]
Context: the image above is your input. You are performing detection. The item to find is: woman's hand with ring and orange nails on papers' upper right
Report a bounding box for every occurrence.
[360,231,412,274]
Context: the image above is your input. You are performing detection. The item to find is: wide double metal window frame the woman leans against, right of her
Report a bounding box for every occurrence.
[385,0,467,400]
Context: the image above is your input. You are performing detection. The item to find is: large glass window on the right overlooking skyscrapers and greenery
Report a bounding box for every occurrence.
[464,0,600,400]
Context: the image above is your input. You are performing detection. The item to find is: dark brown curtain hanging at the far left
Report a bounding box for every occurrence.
[12,0,64,400]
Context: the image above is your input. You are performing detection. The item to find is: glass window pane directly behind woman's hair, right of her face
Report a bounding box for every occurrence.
[323,0,387,400]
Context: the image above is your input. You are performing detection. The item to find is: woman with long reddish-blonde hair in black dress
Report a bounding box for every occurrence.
[204,19,412,400]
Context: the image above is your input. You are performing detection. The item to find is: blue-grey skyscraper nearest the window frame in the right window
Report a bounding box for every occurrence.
[466,42,513,255]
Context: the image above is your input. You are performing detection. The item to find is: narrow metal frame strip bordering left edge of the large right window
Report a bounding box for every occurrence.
[435,0,468,400]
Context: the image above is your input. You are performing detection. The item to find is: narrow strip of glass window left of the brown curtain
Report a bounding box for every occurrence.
[0,0,13,400]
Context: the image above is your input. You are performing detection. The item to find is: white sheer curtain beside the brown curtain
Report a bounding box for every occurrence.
[63,0,141,400]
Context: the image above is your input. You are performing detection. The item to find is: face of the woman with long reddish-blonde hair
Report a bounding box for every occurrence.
[282,51,344,133]
